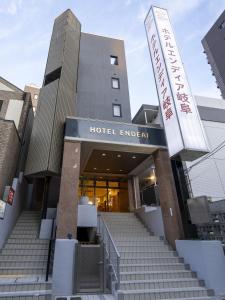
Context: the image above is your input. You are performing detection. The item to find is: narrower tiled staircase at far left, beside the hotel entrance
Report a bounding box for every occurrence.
[0,211,51,300]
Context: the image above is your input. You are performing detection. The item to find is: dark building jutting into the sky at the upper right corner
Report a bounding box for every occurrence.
[202,10,225,99]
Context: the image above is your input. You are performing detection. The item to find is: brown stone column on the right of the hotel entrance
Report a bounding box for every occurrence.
[153,150,184,248]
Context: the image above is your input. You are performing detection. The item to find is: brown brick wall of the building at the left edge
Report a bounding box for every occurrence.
[0,120,20,199]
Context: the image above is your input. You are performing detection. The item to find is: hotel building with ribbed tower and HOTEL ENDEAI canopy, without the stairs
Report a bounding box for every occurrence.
[25,10,183,247]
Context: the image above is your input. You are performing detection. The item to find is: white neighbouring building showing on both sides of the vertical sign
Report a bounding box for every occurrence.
[133,96,225,201]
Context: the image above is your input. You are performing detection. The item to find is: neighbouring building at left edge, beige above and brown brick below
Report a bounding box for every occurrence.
[0,77,33,199]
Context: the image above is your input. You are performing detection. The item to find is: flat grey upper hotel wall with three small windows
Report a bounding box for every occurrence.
[78,33,131,122]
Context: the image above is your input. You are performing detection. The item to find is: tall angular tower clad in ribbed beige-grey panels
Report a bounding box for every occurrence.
[26,10,80,175]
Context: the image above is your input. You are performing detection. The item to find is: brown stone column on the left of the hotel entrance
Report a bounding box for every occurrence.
[56,141,80,239]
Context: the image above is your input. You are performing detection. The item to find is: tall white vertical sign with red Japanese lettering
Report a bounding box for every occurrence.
[145,7,209,161]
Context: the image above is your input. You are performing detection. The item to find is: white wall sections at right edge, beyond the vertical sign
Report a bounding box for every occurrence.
[186,97,225,201]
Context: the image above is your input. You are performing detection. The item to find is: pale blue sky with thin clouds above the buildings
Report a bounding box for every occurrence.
[0,0,225,116]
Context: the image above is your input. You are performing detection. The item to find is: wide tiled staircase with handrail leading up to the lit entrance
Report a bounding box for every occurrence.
[102,213,213,300]
